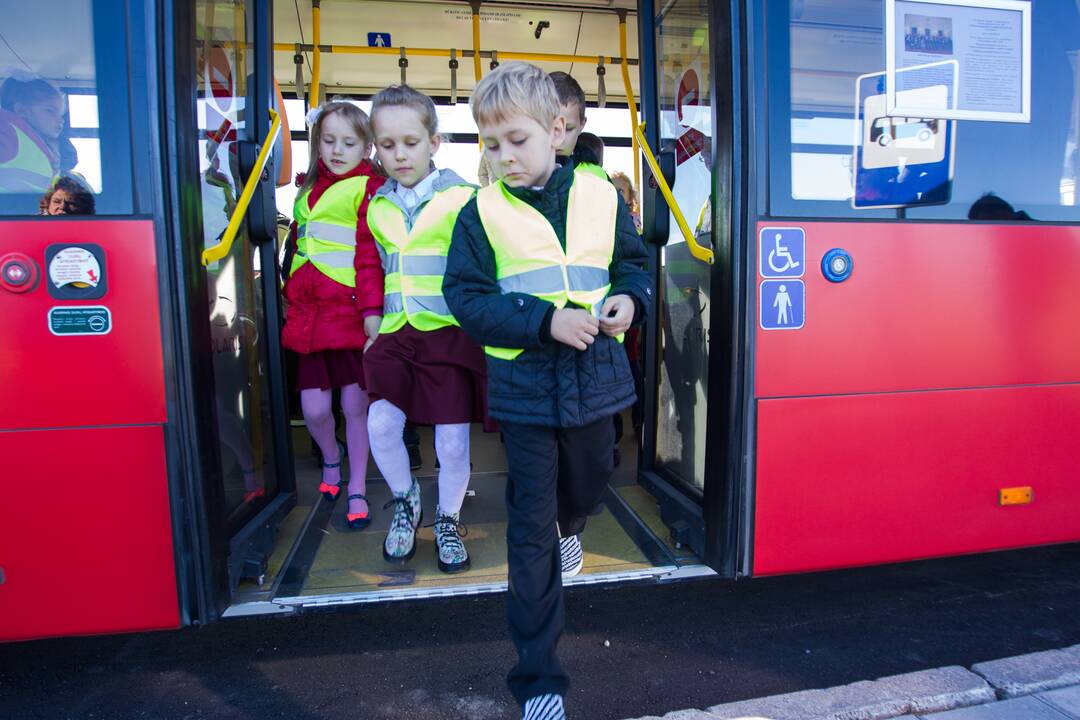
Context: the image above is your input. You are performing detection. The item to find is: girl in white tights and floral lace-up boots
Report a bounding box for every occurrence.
[364,85,486,573]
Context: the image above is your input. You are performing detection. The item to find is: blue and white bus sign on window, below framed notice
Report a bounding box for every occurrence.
[851,60,956,209]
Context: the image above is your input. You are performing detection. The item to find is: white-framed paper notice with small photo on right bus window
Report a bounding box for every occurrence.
[886,0,1031,123]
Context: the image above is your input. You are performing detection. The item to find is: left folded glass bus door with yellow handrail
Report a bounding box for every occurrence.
[176,0,296,613]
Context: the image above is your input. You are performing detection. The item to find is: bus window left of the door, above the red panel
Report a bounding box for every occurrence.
[0,0,132,216]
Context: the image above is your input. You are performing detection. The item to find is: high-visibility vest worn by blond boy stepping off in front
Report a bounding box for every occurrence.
[476,165,619,359]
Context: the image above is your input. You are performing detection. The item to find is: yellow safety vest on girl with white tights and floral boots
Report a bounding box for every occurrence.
[367,185,475,335]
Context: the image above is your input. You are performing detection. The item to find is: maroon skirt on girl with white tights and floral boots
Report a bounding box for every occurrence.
[364,325,491,427]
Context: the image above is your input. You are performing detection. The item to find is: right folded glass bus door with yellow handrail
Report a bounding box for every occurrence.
[639,0,734,574]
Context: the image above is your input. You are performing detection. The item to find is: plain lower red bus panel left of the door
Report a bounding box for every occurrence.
[0,425,180,640]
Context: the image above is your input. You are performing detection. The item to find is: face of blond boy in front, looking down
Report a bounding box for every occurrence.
[480,114,566,188]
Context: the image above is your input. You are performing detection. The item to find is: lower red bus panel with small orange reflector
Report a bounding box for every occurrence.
[754,384,1080,575]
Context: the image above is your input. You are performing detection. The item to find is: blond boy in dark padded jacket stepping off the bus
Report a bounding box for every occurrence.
[443,63,652,720]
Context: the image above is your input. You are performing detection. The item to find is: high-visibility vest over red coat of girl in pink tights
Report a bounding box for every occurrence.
[288,175,367,287]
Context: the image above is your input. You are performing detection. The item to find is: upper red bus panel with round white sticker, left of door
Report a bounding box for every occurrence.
[0,219,165,431]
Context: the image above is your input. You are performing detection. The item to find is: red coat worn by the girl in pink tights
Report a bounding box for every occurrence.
[281,160,386,353]
